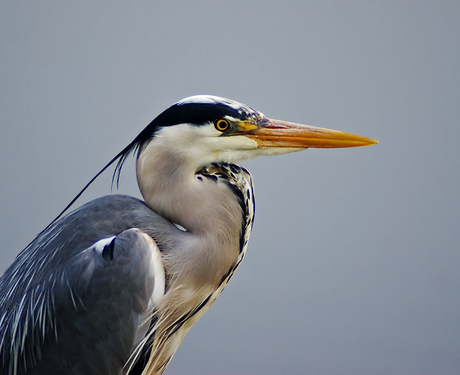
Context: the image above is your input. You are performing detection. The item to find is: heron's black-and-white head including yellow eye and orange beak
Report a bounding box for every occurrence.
[115,95,377,176]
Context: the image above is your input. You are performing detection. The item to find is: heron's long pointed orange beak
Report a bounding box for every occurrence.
[241,119,378,148]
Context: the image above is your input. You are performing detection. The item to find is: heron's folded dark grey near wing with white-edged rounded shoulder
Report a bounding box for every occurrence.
[18,229,164,375]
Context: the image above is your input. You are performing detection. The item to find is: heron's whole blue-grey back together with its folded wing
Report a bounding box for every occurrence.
[0,196,182,375]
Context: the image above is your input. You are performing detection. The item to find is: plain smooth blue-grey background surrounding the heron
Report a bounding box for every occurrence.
[0,0,460,375]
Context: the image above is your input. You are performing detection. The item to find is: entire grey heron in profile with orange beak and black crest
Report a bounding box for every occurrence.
[0,95,377,375]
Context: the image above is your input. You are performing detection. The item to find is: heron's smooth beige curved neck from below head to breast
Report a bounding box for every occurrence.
[137,142,243,282]
